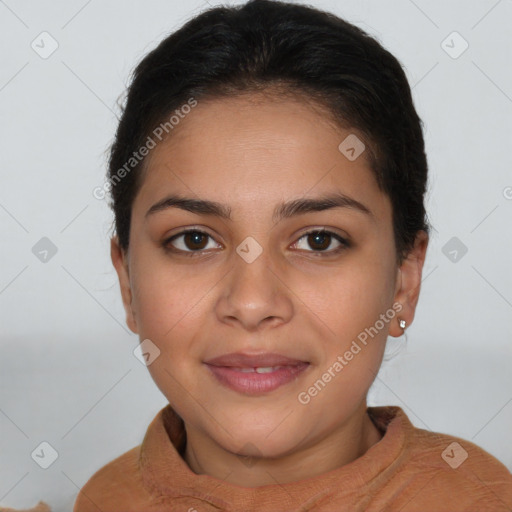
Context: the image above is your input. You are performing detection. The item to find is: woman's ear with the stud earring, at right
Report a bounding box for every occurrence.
[389,230,428,338]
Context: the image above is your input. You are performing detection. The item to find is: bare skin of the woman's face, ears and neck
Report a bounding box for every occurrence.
[111,93,428,487]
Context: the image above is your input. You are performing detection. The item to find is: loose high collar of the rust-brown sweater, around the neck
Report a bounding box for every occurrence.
[139,404,413,511]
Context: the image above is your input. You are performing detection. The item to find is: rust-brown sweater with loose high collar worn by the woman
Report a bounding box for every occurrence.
[73,405,512,512]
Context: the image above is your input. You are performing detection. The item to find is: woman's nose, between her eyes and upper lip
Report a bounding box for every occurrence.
[216,243,294,332]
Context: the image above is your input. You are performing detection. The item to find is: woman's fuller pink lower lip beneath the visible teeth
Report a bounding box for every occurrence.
[206,363,309,395]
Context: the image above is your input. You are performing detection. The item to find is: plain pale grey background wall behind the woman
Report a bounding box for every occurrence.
[0,0,512,511]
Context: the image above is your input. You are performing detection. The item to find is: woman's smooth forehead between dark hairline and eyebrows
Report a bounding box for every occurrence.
[134,94,390,224]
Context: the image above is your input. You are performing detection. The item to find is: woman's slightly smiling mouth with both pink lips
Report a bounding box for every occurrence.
[204,353,310,395]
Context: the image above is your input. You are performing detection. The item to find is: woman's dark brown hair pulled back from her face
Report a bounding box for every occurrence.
[108,0,430,263]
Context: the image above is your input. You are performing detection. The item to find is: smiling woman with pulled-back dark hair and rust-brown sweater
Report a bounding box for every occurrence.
[74,0,512,512]
